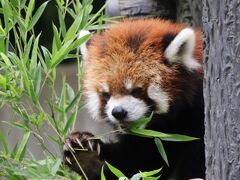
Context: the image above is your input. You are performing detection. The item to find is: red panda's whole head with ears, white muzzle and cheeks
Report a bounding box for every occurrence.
[81,20,202,125]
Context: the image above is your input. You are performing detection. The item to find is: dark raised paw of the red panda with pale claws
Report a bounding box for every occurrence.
[63,132,103,174]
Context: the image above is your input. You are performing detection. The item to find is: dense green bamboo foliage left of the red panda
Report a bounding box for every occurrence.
[0,0,106,179]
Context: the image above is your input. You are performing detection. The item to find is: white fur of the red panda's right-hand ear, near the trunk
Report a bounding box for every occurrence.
[164,28,201,70]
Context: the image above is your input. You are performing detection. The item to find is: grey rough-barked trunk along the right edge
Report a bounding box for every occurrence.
[203,0,240,180]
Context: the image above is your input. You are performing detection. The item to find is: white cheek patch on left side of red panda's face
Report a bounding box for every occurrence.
[86,91,101,120]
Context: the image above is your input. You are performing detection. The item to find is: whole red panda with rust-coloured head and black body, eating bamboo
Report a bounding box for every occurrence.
[64,19,205,180]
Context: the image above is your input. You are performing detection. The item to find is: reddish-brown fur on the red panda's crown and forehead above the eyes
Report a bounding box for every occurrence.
[85,19,203,104]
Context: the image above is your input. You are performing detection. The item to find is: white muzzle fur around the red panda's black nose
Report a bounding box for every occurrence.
[105,95,148,123]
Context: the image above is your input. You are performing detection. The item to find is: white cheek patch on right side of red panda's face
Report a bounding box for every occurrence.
[147,85,169,114]
